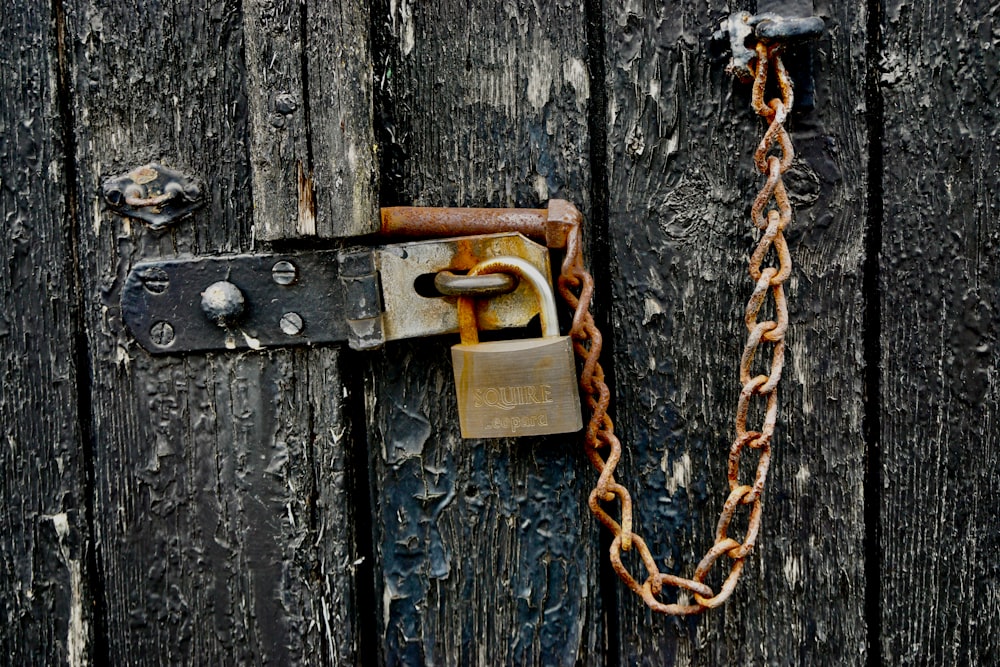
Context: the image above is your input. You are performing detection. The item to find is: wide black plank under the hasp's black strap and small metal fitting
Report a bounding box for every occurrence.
[67,0,357,664]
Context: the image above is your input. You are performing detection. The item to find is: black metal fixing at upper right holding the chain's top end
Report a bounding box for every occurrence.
[712,12,826,108]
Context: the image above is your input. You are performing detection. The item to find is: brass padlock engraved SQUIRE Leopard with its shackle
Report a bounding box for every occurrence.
[451,257,583,438]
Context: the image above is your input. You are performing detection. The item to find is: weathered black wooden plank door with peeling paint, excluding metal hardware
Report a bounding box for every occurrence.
[0,0,1000,665]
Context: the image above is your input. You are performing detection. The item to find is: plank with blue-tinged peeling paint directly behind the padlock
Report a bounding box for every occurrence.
[367,0,604,665]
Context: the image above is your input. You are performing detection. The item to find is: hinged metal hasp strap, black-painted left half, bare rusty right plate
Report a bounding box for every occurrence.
[122,233,551,354]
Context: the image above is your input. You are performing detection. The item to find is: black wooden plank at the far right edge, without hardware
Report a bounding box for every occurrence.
[879,1,1000,665]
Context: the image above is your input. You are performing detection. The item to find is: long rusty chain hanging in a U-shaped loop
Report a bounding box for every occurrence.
[559,44,794,615]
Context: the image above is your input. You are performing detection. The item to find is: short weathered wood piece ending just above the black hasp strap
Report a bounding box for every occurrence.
[244,0,379,241]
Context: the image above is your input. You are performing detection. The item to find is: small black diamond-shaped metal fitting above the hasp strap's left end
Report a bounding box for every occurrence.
[102,162,204,231]
